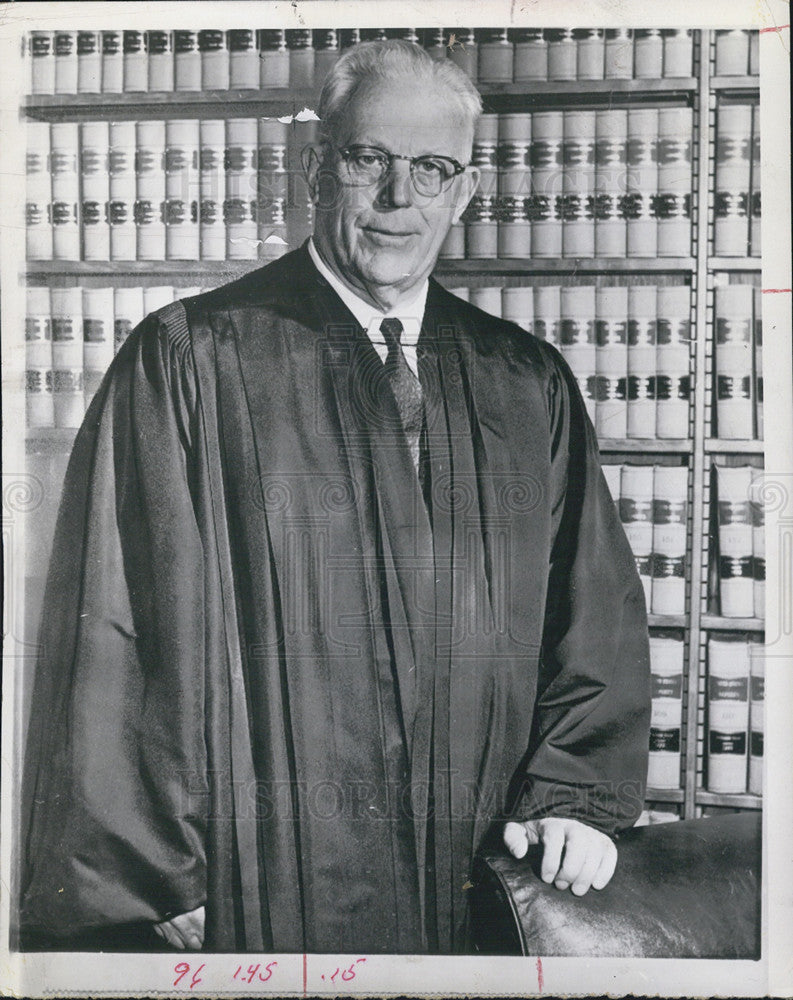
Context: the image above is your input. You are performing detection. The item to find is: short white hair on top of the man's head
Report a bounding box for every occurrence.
[318,38,482,142]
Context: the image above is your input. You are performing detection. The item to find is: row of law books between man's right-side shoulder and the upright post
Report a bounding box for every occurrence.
[452,285,691,439]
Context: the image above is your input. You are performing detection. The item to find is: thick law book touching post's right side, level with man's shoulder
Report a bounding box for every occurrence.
[714,284,754,440]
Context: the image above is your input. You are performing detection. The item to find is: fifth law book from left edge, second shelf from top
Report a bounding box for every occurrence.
[135,121,166,260]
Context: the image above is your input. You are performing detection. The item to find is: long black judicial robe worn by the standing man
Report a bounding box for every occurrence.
[21,246,650,953]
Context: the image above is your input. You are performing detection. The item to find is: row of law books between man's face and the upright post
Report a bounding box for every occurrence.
[441,107,693,259]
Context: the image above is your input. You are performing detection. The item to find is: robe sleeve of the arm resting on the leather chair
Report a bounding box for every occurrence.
[518,344,651,835]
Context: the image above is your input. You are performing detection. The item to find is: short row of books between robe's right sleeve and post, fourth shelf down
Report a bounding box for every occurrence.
[603,462,688,615]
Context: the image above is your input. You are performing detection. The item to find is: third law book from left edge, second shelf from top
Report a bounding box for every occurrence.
[80,121,110,260]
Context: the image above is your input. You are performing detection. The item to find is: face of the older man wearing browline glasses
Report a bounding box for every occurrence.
[309,79,477,305]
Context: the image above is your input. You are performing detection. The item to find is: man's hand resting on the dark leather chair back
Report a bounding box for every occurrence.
[504,816,617,896]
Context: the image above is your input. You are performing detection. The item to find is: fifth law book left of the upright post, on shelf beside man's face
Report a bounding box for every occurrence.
[528,111,564,258]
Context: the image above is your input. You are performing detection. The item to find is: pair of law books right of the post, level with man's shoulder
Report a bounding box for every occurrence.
[712,284,764,440]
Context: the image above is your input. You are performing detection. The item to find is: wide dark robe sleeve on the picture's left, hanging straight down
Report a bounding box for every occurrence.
[20,305,207,939]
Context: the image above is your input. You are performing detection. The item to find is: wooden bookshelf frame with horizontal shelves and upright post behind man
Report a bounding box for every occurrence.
[20,31,764,818]
